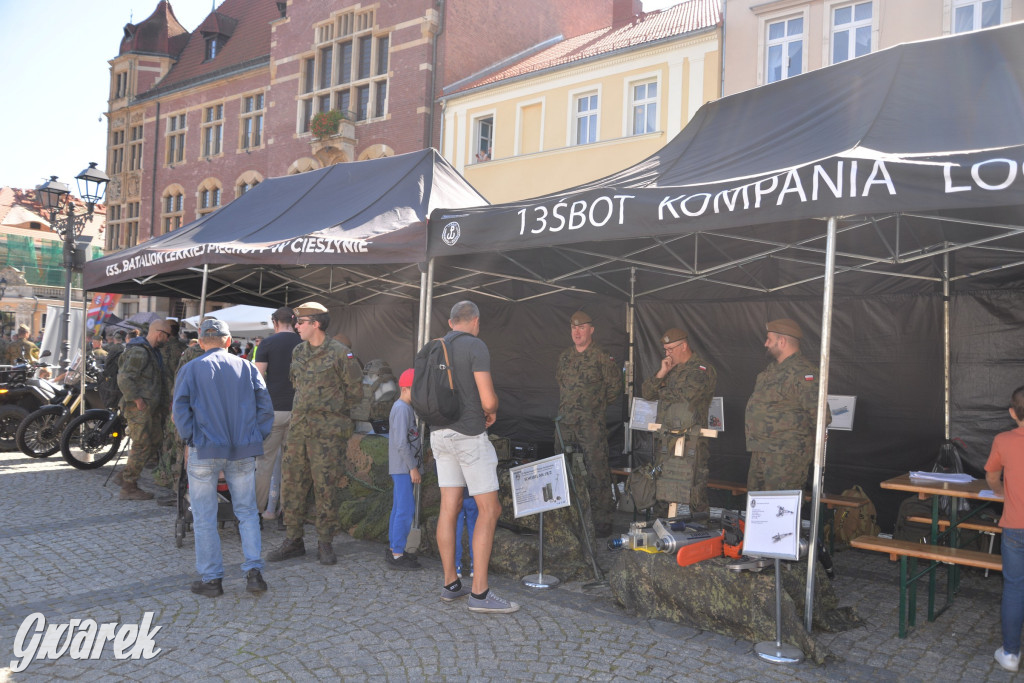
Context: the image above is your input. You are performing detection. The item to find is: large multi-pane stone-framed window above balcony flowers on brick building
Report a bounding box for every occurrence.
[299,9,391,133]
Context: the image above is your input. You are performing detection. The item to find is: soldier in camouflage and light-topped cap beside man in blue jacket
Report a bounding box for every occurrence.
[267,302,362,564]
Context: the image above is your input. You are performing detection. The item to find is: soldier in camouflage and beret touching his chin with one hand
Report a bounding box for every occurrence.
[641,328,718,512]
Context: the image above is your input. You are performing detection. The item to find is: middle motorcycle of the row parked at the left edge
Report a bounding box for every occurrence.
[15,357,102,458]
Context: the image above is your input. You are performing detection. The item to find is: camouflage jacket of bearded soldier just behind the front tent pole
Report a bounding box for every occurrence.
[743,352,831,453]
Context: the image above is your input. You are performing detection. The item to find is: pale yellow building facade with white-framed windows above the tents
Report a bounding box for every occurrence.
[441,0,721,203]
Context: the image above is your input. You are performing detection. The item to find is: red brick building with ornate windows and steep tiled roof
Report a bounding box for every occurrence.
[105,0,613,266]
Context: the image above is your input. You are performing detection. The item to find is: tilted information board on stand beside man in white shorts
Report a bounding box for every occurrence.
[509,454,569,588]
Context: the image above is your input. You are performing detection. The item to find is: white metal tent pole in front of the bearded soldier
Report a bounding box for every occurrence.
[804,216,839,633]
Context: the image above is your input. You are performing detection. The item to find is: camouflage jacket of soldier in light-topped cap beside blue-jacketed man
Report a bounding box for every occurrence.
[289,339,362,439]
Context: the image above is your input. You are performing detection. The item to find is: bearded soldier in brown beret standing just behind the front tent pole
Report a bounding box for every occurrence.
[744,318,831,490]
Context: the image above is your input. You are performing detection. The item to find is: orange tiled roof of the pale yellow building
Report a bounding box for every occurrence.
[444,0,722,95]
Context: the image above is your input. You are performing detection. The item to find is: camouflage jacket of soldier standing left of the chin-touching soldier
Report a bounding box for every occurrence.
[555,343,623,424]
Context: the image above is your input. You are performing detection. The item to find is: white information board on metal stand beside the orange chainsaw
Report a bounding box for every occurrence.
[743,490,804,664]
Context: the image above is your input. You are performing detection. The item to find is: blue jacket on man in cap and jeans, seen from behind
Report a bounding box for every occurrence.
[173,348,273,460]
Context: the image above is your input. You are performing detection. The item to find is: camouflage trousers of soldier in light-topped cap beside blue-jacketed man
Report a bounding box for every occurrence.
[281,430,347,542]
